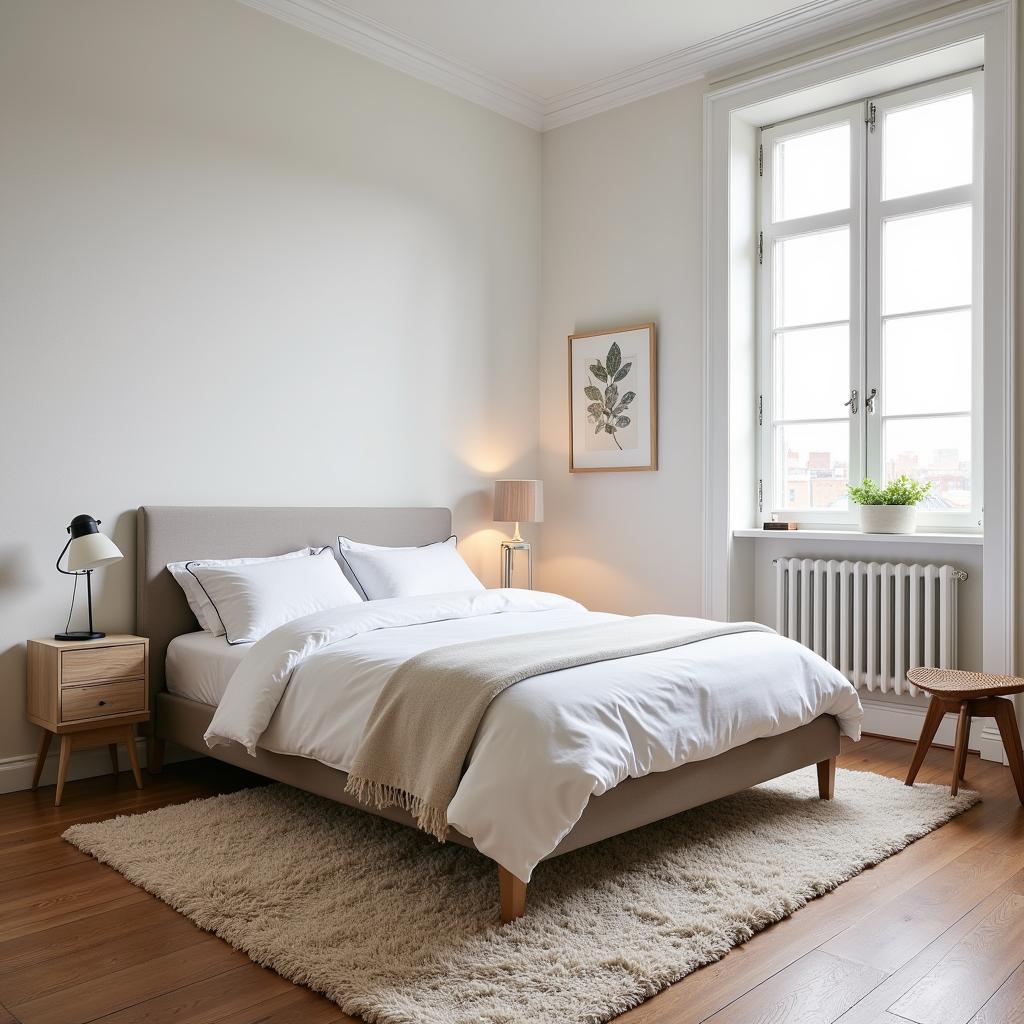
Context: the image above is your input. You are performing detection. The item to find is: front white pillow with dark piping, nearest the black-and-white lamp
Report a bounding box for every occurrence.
[188,548,362,644]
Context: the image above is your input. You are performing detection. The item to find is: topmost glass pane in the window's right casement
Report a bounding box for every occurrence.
[882,92,974,199]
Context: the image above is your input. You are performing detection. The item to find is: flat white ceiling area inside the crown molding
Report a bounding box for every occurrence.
[329,0,803,99]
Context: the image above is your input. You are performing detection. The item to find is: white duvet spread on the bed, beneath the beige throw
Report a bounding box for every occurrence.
[206,590,863,882]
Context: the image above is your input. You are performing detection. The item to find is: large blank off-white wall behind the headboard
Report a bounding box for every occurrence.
[0,0,541,762]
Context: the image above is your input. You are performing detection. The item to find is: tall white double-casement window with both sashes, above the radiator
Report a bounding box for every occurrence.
[758,72,982,529]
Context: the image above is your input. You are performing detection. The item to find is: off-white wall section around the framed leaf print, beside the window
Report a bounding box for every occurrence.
[538,83,705,614]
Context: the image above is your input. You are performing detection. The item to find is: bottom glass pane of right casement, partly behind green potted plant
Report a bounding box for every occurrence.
[882,416,971,511]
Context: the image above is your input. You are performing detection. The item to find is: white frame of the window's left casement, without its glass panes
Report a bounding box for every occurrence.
[758,102,865,525]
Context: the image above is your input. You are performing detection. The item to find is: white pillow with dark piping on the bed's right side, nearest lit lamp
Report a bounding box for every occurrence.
[338,537,483,601]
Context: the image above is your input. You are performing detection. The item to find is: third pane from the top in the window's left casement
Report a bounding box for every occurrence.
[775,327,850,420]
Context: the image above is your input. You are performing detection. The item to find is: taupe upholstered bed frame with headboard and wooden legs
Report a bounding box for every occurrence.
[137,506,840,922]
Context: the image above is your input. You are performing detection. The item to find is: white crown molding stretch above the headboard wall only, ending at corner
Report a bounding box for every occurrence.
[239,0,544,131]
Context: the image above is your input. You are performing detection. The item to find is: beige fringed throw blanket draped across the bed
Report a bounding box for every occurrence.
[345,615,771,842]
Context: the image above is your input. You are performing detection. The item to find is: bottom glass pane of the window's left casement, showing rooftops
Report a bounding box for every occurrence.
[775,420,850,510]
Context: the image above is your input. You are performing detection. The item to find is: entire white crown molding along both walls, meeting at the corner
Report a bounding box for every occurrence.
[239,0,941,131]
